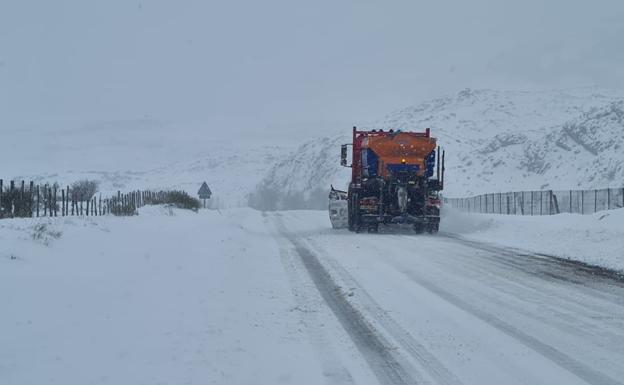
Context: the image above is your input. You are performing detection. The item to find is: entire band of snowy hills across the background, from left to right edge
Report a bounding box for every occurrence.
[6,88,624,210]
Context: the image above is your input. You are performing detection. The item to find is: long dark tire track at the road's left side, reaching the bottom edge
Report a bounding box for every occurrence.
[278,218,425,385]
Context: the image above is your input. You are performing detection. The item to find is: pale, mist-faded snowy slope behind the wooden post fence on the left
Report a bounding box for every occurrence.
[0,119,296,208]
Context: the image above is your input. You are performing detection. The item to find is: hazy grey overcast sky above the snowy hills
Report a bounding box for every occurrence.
[0,0,624,138]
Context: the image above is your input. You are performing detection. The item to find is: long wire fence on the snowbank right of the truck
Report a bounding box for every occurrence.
[444,188,624,215]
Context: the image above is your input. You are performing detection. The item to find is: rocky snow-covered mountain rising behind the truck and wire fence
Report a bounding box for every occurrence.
[251,88,624,209]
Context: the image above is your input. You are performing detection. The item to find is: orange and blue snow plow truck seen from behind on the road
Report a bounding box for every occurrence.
[329,127,444,233]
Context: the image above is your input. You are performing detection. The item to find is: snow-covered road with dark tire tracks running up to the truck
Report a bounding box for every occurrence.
[271,212,624,384]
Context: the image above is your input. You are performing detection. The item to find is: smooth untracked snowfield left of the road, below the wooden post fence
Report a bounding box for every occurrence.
[0,207,357,385]
